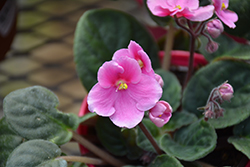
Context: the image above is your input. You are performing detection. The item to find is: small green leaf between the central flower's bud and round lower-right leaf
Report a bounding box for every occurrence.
[163,111,198,131]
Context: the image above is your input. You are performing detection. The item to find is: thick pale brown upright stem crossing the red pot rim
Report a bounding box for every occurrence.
[162,22,175,70]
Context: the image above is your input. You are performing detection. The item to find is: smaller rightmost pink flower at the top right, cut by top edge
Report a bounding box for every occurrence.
[213,0,238,28]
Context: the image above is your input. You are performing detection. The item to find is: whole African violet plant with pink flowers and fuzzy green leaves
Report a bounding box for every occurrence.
[0,0,250,167]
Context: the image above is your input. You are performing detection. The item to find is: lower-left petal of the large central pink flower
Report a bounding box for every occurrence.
[87,83,118,116]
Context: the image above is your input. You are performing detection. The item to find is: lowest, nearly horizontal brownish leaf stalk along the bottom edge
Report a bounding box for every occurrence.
[56,156,107,165]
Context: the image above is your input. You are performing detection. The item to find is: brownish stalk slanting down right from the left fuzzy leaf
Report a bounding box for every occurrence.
[72,131,125,167]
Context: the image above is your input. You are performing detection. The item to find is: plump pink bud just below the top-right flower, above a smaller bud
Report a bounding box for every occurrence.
[207,19,224,38]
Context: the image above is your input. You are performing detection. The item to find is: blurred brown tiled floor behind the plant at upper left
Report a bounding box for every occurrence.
[0,0,150,154]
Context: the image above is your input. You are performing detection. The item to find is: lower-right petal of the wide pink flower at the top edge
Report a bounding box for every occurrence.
[187,5,214,21]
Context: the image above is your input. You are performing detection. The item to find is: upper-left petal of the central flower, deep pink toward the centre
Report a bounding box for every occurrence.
[97,61,124,88]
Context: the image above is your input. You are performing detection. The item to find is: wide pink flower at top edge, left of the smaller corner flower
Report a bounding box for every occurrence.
[147,0,214,21]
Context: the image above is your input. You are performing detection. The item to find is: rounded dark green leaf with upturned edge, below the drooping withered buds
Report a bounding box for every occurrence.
[160,120,217,161]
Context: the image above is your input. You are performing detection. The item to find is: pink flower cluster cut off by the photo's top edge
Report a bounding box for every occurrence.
[147,0,238,28]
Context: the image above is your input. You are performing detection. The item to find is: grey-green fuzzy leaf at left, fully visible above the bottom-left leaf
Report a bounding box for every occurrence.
[3,86,79,145]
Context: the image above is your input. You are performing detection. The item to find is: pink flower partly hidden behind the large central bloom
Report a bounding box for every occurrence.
[112,41,154,77]
